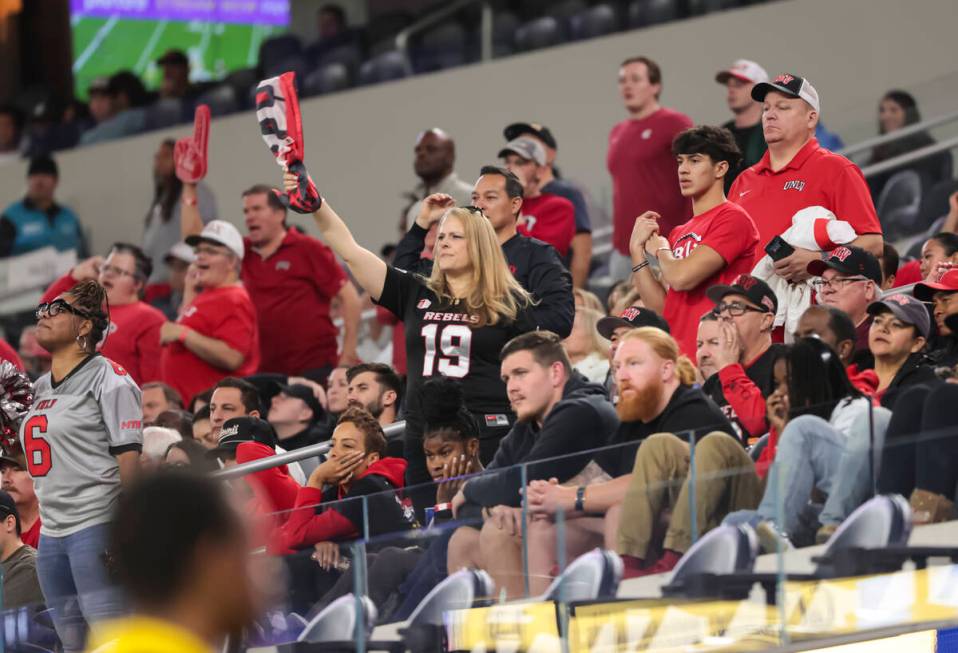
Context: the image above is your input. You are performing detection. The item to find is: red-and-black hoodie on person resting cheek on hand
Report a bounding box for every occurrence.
[268,458,415,554]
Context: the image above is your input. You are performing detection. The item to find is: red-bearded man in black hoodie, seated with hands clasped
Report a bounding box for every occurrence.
[527,327,736,575]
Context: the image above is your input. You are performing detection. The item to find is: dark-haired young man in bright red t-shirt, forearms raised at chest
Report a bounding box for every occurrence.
[629,126,758,360]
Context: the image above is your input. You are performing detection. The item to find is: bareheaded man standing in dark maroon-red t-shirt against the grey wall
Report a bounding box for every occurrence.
[606,57,693,279]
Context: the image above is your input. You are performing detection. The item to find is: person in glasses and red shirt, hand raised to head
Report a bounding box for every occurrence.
[40,243,166,385]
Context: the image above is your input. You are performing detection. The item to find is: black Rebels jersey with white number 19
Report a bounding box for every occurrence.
[377,266,536,483]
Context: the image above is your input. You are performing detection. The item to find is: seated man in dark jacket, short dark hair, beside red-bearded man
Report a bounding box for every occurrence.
[449,331,619,598]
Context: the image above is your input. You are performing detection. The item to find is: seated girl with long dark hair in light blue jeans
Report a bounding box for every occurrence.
[726,338,891,546]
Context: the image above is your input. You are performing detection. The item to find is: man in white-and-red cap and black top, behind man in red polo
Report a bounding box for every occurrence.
[715,59,768,194]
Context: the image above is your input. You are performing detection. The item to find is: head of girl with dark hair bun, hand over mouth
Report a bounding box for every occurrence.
[422,376,480,481]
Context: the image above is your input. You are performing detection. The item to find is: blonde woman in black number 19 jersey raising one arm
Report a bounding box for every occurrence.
[284,173,537,496]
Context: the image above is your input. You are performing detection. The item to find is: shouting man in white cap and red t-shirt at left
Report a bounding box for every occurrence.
[160,220,259,402]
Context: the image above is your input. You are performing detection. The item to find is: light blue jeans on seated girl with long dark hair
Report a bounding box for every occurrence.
[724,407,891,543]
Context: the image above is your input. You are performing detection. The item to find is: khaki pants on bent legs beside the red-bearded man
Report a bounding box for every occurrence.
[617,432,762,559]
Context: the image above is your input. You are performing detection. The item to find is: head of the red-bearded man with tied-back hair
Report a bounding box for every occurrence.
[612,327,695,422]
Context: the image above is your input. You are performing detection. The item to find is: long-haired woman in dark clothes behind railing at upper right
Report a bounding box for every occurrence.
[868,89,951,200]
